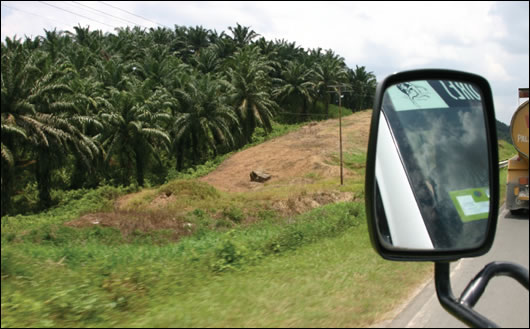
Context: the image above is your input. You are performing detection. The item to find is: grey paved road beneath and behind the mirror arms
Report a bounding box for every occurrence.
[388,207,529,328]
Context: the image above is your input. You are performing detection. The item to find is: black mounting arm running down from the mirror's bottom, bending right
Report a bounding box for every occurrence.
[434,262,499,328]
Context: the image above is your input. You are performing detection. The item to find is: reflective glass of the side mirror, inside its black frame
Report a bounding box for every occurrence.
[375,80,490,250]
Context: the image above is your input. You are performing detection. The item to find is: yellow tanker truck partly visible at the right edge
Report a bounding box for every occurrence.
[506,88,529,213]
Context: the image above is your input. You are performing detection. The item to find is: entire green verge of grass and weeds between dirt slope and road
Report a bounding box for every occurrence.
[1,190,430,327]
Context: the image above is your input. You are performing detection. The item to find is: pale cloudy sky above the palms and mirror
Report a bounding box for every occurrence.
[2,1,530,124]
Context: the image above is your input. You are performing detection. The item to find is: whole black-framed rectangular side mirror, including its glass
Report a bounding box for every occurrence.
[365,70,499,261]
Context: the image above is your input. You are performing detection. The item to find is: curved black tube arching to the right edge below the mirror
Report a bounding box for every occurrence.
[458,262,529,307]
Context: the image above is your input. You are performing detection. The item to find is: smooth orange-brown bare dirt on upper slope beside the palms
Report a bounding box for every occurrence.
[200,111,372,192]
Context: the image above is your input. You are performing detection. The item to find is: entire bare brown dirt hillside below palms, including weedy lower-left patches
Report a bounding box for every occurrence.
[65,111,372,236]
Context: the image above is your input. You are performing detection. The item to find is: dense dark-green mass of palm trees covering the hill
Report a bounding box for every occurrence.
[1,24,376,215]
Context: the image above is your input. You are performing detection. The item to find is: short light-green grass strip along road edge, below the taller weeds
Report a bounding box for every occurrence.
[128,222,430,328]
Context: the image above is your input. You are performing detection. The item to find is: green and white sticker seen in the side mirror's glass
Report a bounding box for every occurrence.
[449,187,490,223]
